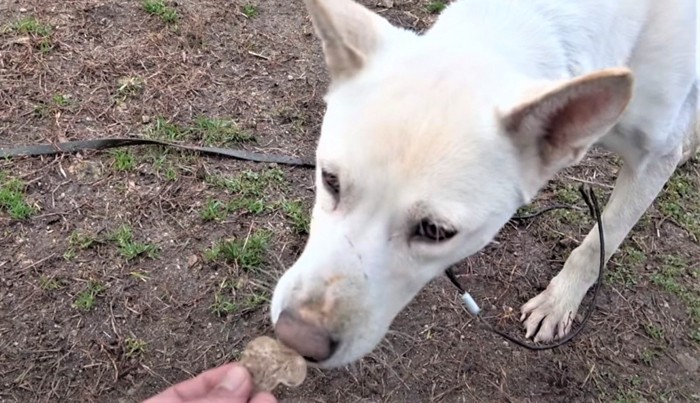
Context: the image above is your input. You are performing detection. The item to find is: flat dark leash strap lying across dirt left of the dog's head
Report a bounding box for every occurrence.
[0,138,314,168]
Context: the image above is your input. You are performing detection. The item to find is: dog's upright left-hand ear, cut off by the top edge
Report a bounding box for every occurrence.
[305,0,396,81]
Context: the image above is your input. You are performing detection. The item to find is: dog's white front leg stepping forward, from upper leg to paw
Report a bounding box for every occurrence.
[521,149,681,342]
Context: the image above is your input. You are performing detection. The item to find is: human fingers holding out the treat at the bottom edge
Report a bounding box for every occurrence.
[143,363,277,403]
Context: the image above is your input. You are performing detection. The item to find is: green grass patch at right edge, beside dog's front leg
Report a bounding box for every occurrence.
[658,170,700,241]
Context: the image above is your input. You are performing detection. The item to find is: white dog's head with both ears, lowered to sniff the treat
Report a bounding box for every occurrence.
[272,0,632,367]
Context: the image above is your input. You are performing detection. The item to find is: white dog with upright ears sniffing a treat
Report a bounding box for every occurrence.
[272,0,700,367]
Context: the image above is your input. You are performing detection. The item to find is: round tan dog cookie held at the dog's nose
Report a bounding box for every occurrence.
[239,336,306,392]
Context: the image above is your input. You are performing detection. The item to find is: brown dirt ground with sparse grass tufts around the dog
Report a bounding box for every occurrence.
[0,0,700,402]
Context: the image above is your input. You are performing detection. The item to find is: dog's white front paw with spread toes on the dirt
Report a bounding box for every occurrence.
[520,277,585,343]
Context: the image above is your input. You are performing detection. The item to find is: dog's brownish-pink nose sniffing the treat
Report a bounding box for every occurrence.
[275,309,338,362]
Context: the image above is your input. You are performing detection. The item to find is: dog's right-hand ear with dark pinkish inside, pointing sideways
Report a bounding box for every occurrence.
[502,68,633,170]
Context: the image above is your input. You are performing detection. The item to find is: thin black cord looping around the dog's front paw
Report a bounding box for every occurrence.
[445,185,605,351]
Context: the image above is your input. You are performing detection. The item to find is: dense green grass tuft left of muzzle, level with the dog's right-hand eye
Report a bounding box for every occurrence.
[204,230,270,271]
